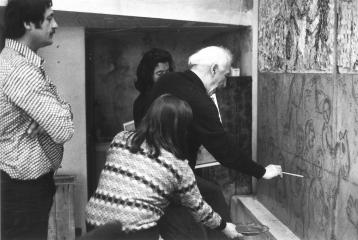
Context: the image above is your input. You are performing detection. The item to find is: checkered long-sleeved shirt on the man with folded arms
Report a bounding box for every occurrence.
[0,39,74,180]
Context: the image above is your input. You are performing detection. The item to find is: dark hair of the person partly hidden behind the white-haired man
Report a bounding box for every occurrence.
[134,48,174,93]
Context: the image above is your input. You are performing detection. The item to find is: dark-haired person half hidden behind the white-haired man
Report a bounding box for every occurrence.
[133,48,174,127]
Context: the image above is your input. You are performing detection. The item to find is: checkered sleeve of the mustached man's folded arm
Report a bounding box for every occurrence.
[3,64,74,143]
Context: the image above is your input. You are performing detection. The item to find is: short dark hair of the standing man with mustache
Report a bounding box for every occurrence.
[4,0,52,39]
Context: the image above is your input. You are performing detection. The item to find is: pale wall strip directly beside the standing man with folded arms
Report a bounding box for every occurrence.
[39,26,87,231]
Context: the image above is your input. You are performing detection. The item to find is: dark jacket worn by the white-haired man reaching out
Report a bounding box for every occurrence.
[134,71,265,178]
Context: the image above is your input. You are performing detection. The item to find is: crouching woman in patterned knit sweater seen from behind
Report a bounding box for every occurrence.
[86,94,241,240]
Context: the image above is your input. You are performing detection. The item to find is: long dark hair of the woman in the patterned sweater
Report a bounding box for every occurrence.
[129,94,193,159]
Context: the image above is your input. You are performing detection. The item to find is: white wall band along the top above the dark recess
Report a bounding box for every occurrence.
[53,0,252,26]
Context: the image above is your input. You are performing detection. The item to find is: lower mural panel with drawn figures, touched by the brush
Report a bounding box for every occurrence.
[258,73,358,240]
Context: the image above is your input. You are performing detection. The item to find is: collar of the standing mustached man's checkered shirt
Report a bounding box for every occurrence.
[5,38,44,67]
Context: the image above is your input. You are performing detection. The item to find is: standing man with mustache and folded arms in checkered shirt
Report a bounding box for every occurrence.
[0,0,74,240]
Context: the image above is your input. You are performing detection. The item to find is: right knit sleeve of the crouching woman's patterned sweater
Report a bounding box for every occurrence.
[176,162,226,230]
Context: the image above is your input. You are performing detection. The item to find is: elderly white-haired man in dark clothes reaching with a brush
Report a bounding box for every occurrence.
[137,46,282,240]
